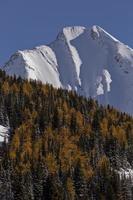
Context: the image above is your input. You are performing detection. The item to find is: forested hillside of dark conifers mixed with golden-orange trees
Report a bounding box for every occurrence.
[0,71,133,200]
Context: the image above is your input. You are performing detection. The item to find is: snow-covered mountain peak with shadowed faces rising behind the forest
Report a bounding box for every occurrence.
[3,26,133,114]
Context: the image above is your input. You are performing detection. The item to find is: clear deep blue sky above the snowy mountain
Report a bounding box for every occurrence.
[0,0,133,65]
